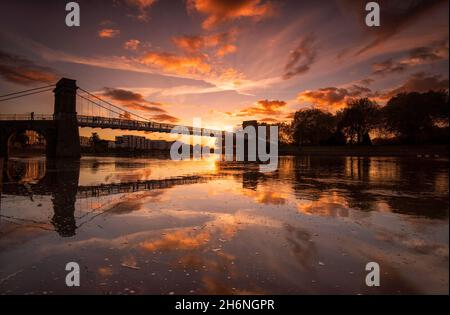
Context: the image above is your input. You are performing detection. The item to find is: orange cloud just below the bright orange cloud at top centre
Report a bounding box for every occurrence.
[172,29,237,57]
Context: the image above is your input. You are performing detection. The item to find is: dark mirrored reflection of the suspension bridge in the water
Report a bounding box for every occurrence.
[0,159,216,237]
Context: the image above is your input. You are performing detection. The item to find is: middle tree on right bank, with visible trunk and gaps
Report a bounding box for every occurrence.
[336,98,381,145]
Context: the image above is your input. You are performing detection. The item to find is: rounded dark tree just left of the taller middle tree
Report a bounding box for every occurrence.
[292,109,336,145]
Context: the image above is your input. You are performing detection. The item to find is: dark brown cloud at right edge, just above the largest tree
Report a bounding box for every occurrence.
[381,72,449,99]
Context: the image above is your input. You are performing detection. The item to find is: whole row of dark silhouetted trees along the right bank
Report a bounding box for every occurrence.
[279,91,449,146]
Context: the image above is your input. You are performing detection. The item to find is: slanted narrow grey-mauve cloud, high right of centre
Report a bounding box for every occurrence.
[283,35,317,80]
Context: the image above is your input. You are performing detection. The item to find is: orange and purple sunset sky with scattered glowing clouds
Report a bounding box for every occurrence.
[0,0,449,138]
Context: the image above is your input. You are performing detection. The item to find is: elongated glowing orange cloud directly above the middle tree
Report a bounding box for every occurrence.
[297,85,377,111]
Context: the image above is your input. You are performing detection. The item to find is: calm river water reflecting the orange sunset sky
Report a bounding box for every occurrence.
[0,157,449,295]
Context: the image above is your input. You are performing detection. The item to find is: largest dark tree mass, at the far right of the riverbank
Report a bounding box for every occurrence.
[383,91,449,144]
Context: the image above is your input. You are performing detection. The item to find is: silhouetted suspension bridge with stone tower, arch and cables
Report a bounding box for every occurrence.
[0,78,232,158]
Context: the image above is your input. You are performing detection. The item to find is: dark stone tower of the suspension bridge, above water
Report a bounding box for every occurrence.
[53,78,81,158]
